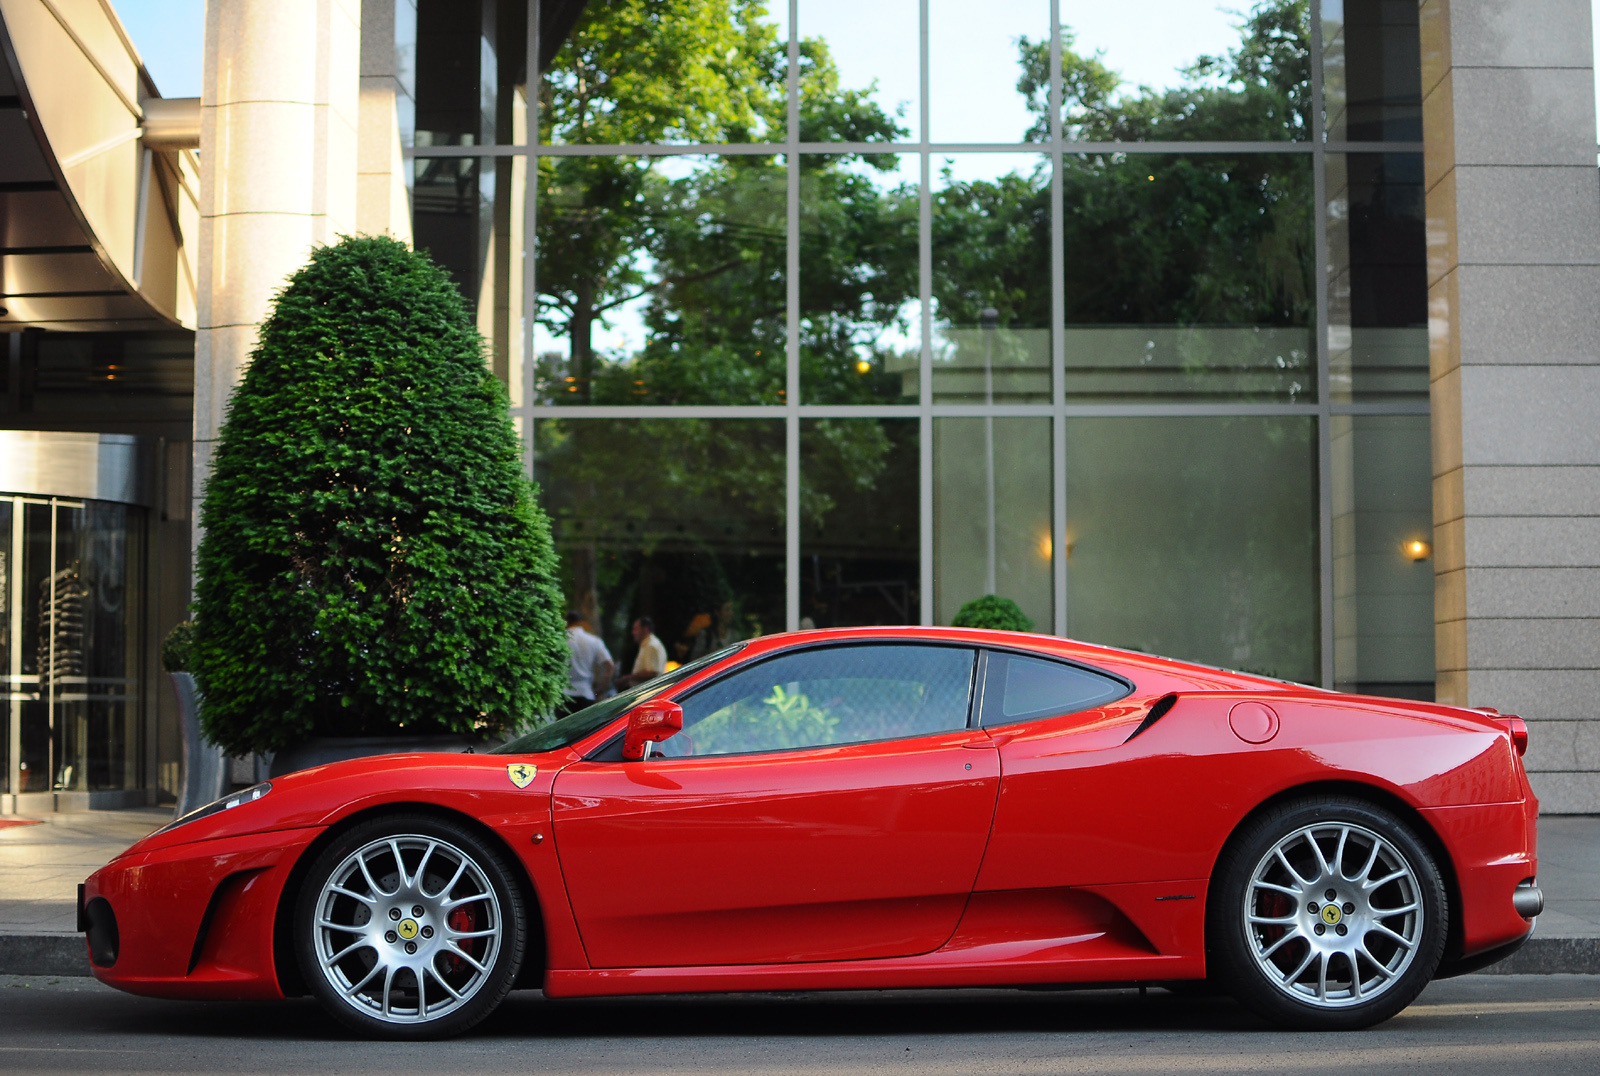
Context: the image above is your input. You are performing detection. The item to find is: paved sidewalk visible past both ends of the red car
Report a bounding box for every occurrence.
[0,807,1600,975]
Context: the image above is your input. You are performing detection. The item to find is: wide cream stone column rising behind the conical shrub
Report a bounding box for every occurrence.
[192,0,362,528]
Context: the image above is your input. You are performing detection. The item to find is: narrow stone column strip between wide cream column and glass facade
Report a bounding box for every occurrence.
[355,0,416,243]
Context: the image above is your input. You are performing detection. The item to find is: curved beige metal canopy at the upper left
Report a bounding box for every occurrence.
[0,0,198,331]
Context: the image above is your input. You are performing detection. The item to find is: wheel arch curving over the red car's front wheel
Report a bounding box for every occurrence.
[272,801,547,998]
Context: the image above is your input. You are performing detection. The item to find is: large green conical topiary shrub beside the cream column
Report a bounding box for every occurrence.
[194,239,566,754]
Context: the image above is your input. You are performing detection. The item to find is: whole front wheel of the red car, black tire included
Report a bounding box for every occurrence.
[294,813,526,1039]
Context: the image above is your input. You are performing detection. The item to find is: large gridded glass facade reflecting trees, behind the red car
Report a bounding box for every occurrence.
[402,0,1432,695]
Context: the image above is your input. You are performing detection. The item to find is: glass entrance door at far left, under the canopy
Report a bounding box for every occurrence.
[0,496,144,794]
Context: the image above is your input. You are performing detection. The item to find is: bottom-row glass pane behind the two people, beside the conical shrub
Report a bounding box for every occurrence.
[534,420,784,671]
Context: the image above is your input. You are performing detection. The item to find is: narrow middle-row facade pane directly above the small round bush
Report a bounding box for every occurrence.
[933,154,1051,404]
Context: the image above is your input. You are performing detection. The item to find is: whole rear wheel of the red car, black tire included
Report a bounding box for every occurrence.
[1206,796,1450,1031]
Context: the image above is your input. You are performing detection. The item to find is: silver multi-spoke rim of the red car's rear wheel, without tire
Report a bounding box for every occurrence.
[1243,821,1426,1009]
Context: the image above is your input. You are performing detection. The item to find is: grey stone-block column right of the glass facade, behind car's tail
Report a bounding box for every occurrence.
[1421,0,1600,813]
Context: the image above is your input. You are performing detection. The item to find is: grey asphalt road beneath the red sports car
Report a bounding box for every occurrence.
[0,975,1600,1076]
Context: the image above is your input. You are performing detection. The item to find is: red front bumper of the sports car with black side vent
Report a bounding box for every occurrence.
[82,829,322,999]
